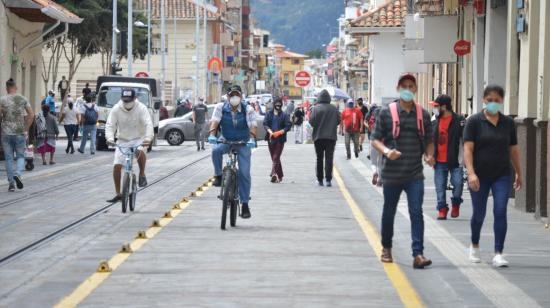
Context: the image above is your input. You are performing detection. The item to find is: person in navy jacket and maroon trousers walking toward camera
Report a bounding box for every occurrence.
[264,97,291,183]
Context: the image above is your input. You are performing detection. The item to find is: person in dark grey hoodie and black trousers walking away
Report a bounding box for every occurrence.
[309,90,341,187]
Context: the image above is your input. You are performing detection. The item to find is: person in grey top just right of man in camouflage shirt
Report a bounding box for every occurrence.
[36,105,59,165]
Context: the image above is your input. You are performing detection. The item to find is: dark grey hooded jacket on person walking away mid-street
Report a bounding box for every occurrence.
[309,90,341,141]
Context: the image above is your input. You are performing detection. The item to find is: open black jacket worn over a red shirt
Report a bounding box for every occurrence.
[434,112,466,168]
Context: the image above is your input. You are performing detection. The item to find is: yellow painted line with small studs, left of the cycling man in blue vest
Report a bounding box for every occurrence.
[54,183,212,308]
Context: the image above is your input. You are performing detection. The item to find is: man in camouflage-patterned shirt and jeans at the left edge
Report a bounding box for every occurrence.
[0,78,34,192]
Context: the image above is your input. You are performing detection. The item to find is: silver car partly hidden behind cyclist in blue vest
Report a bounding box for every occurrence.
[158,105,265,145]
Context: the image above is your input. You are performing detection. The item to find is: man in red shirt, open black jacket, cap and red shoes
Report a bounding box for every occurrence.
[433,95,465,220]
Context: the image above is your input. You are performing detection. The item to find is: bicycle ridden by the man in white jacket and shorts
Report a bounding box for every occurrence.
[116,139,143,213]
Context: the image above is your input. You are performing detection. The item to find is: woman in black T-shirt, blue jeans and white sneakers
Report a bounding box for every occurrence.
[464,85,522,267]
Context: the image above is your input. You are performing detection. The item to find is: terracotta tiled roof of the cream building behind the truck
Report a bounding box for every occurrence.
[136,0,218,19]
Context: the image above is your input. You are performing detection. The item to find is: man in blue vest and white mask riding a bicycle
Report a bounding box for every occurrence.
[208,86,257,219]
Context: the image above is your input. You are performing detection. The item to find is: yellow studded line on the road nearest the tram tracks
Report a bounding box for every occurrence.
[54,179,212,308]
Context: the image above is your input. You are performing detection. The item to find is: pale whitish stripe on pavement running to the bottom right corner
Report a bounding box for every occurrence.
[351,160,541,308]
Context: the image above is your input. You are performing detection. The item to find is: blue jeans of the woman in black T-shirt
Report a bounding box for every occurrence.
[470,175,512,253]
